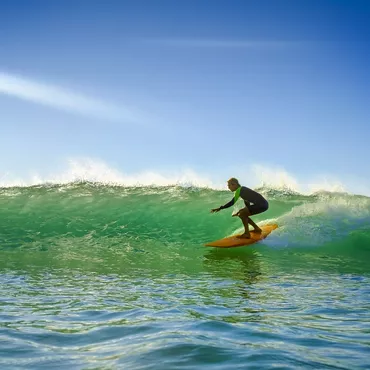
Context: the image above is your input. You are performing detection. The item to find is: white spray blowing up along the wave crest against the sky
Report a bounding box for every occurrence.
[0,158,370,195]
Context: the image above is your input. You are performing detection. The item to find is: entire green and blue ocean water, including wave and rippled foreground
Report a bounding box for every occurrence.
[0,182,370,370]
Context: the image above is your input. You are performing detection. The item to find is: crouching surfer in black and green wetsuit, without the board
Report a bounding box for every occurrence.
[211,177,269,238]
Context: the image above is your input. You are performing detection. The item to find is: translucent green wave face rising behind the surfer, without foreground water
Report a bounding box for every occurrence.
[0,183,370,250]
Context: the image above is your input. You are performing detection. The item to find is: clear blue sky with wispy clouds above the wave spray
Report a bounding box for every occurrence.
[0,0,370,193]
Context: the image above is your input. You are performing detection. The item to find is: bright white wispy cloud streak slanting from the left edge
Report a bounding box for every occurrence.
[0,72,138,122]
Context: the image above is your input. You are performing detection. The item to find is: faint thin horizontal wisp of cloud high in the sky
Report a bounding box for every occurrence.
[143,38,302,49]
